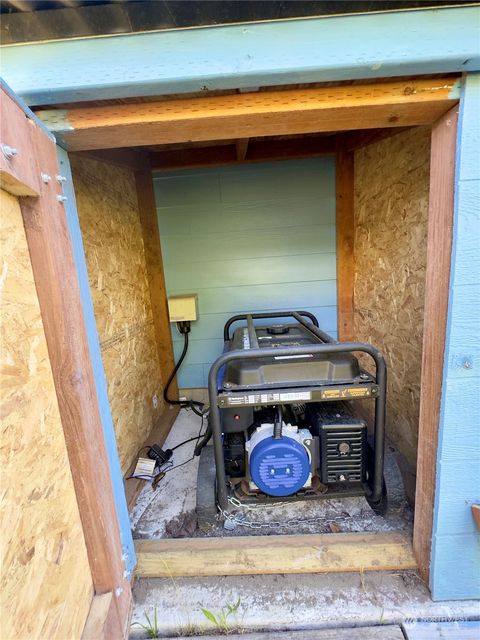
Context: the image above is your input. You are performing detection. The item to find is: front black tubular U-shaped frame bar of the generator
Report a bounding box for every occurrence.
[208,340,387,512]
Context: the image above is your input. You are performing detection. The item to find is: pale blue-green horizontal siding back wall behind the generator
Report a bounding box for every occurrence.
[155,158,337,388]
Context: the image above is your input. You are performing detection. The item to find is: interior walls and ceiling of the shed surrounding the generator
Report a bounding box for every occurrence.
[66,117,431,528]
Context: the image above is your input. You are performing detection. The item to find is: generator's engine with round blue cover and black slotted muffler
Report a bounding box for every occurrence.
[223,402,367,497]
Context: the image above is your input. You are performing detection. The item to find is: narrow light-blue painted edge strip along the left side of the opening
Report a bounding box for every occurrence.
[57,147,136,579]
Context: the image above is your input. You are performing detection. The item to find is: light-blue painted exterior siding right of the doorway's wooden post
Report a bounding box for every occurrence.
[431,74,480,600]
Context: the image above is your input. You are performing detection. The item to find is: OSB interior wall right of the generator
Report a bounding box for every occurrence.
[355,127,430,465]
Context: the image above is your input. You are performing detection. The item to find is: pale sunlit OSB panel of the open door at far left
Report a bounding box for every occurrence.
[0,191,93,640]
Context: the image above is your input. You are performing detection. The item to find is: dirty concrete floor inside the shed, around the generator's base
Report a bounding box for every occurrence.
[131,409,413,539]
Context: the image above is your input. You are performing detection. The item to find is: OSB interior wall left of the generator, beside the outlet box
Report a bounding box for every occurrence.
[72,157,163,473]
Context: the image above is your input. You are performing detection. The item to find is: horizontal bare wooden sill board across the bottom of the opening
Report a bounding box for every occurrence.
[136,533,416,578]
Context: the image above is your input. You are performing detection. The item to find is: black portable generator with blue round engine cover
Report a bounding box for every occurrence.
[197,311,387,528]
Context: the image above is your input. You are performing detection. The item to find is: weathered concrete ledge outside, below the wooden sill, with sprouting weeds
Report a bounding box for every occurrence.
[131,571,480,639]
